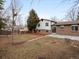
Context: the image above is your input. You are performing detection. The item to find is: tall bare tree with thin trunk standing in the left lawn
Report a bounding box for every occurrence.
[1,0,21,44]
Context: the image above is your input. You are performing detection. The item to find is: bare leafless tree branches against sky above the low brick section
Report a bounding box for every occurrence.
[61,0,79,21]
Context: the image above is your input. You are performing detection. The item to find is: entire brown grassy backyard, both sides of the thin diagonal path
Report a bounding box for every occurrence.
[0,34,79,59]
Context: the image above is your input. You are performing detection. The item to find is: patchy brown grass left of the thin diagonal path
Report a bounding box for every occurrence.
[0,34,42,48]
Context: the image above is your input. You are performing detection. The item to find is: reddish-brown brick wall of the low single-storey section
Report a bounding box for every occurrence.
[56,25,79,36]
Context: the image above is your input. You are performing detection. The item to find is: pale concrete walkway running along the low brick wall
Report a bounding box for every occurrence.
[48,33,79,40]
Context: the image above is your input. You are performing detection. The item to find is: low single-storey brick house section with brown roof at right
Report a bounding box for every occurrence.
[52,21,79,36]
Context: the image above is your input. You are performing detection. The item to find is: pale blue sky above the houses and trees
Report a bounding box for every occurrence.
[4,0,74,23]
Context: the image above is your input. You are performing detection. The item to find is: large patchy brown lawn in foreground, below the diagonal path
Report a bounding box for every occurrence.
[0,37,79,59]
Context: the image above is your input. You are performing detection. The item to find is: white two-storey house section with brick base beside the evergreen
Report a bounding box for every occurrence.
[37,19,56,33]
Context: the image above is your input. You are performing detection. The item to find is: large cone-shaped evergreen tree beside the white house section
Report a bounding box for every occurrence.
[27,9,39,32]
